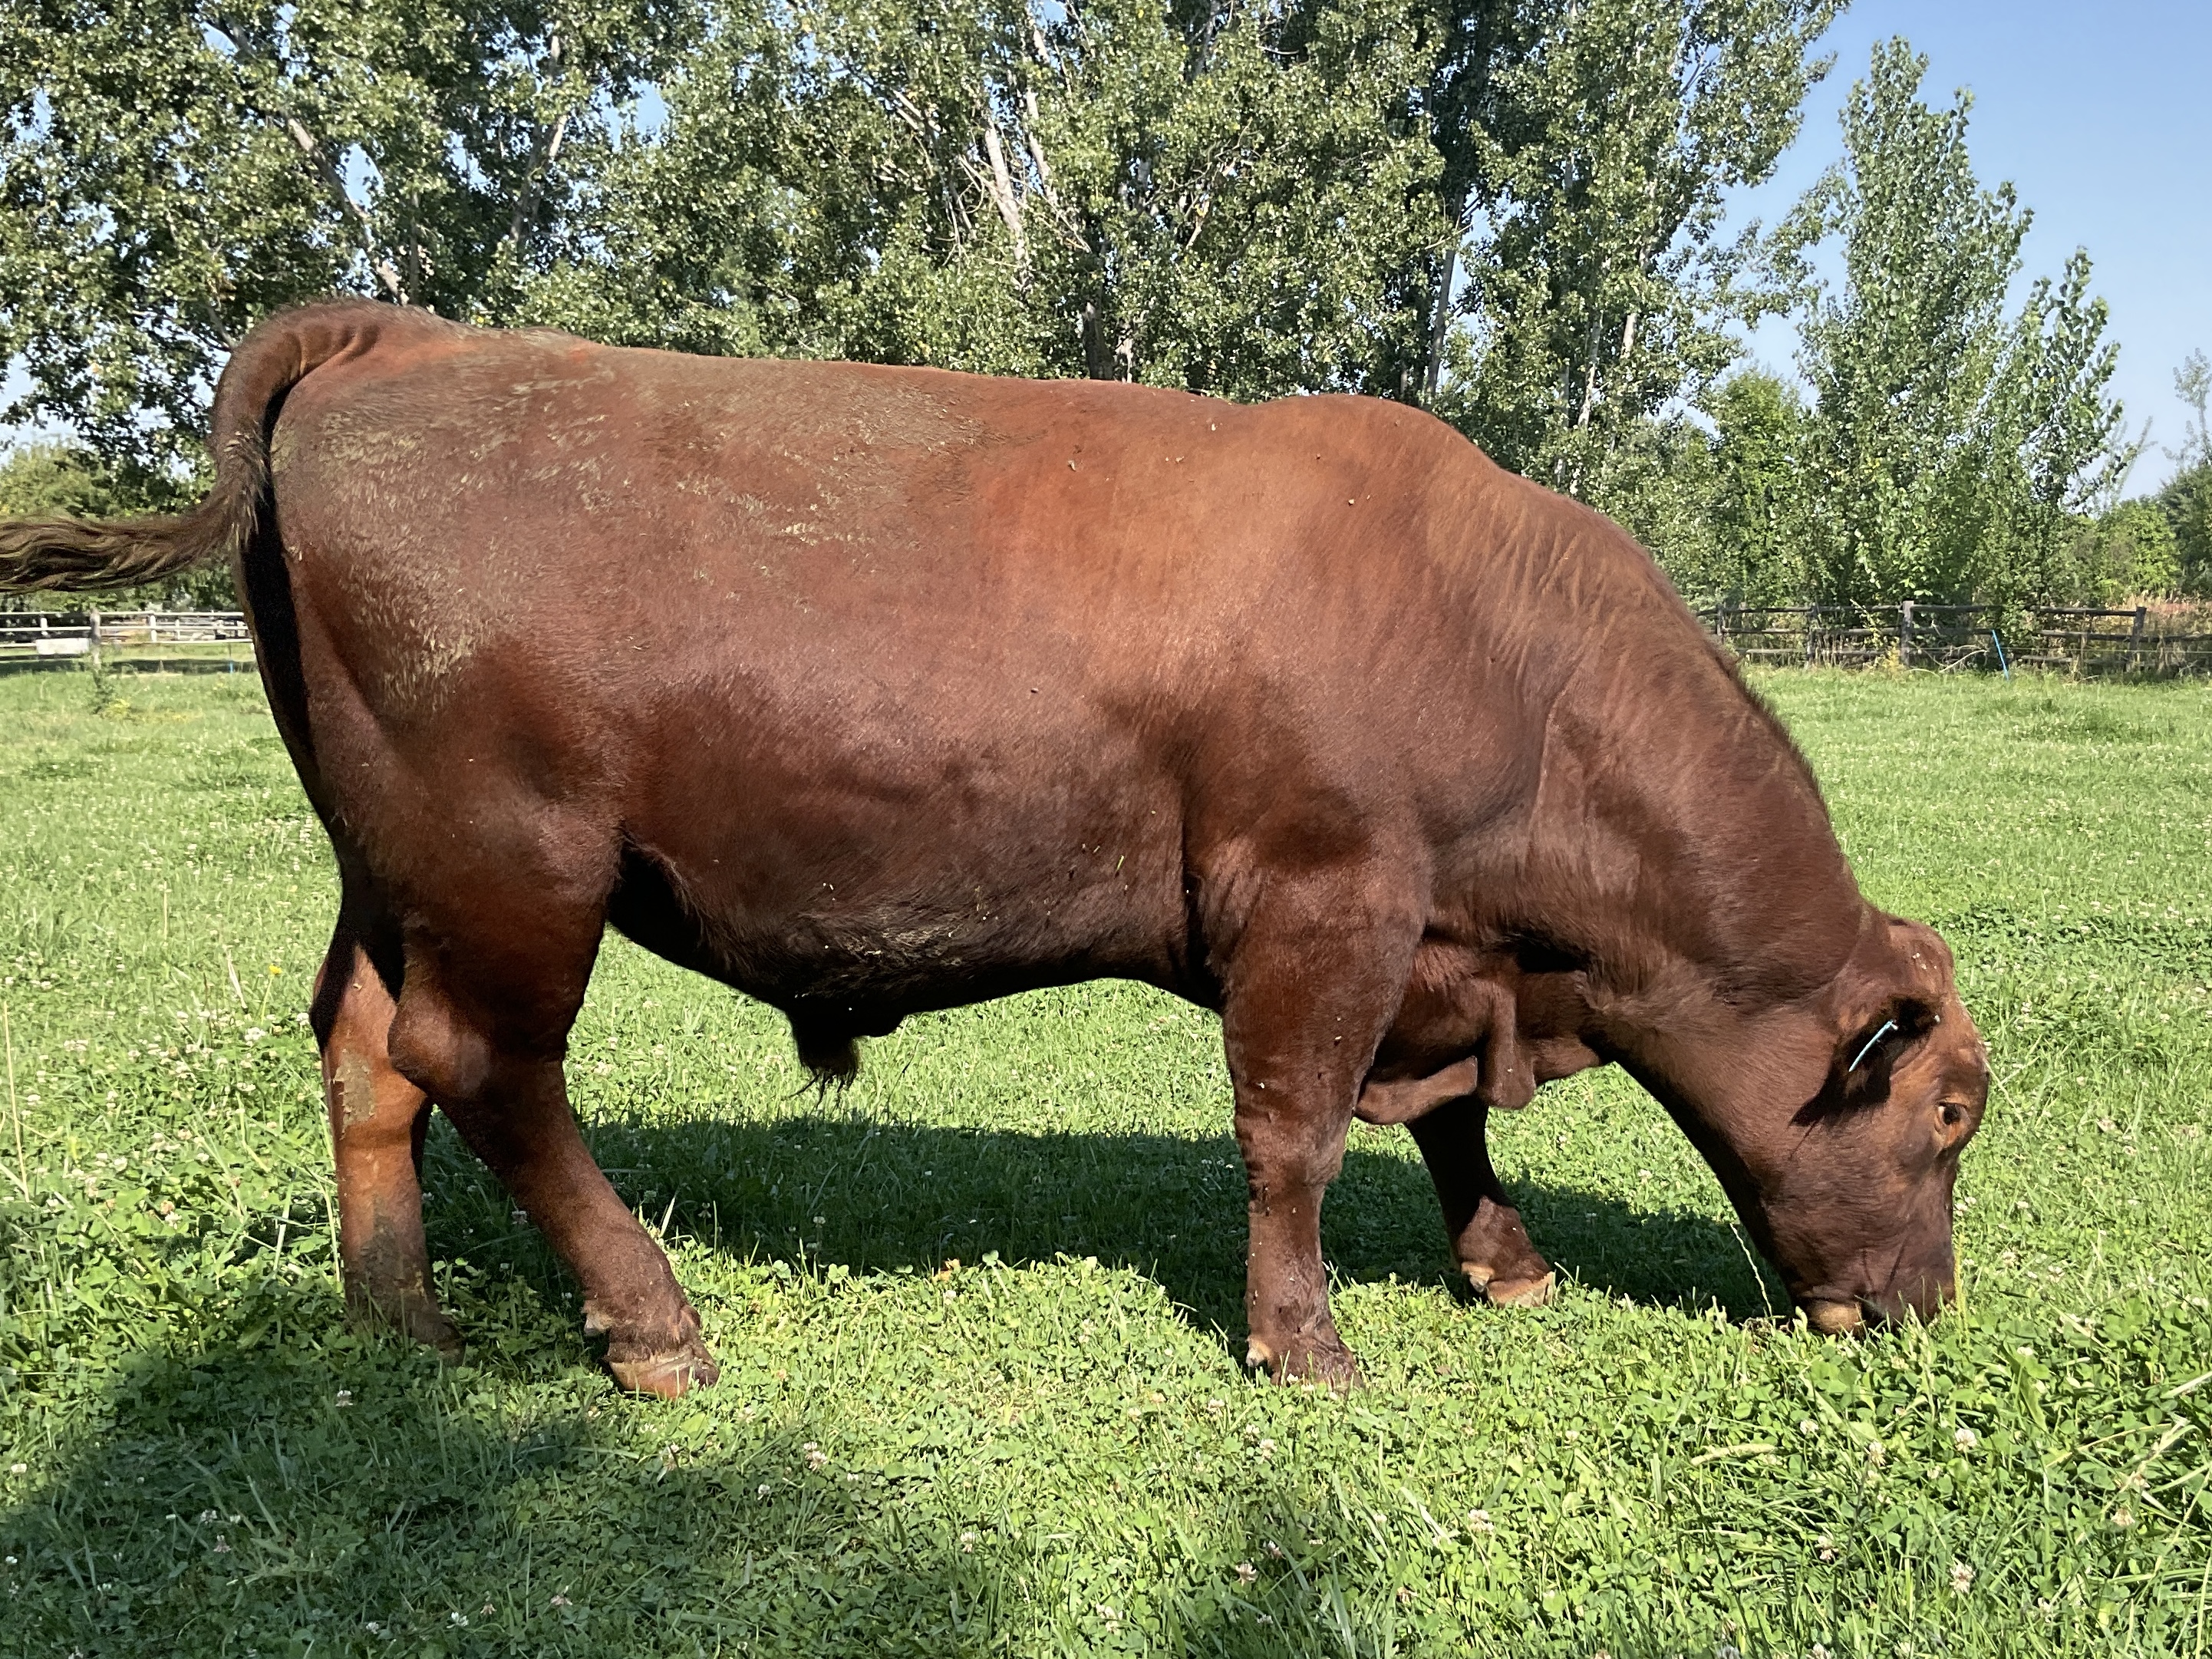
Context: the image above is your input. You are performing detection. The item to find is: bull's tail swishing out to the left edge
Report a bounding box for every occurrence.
[0,301,411,593]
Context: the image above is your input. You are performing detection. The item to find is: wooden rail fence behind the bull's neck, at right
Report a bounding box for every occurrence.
[1699,602,2212,677]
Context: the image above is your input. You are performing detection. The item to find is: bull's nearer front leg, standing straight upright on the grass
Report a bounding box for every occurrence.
[1221,876,1420,1387]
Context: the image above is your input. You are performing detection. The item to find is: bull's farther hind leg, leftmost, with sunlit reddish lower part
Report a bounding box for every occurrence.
[310,894,460,1356]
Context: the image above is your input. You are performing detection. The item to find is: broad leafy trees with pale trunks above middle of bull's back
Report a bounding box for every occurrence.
[536,0,1438,396]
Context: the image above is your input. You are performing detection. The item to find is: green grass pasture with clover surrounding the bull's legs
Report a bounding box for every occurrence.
[0,672,2212,1659]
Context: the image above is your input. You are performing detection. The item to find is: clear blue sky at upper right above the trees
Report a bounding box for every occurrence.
[1732,0,2212,493]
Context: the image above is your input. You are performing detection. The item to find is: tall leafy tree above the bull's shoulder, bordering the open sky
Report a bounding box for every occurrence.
[1429,0,1841,518]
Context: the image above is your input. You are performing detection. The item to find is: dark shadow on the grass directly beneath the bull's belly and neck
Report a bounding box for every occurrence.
[425,1100,1789,1336]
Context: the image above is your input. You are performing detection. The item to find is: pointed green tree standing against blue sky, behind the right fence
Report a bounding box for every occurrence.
[1776,40,2124,606]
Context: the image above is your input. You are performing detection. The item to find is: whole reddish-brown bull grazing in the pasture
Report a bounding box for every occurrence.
[0,305,1989,1393]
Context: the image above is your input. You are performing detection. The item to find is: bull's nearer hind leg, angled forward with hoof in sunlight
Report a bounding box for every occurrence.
[391,911,714,1398]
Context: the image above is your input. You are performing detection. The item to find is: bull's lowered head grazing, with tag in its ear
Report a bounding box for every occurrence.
[1637,909,1989,1331]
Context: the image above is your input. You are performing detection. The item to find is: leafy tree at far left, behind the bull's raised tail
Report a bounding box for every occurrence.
[0,0,688,498]
